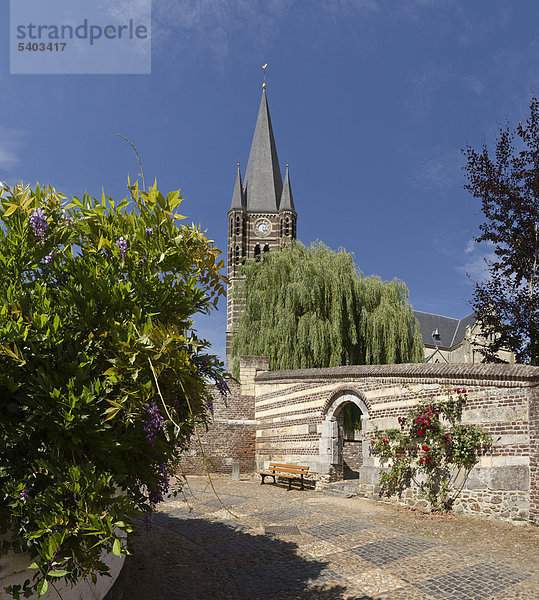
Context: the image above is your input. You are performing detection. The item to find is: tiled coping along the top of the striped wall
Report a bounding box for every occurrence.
[255,363,539,387]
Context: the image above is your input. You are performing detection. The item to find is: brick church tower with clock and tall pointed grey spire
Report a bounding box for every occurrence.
[226,83,297,369]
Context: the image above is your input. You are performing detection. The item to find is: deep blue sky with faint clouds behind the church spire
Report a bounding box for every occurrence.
[0,0,539,355]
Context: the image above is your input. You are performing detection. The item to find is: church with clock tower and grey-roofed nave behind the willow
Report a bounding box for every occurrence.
[226,83,514,369]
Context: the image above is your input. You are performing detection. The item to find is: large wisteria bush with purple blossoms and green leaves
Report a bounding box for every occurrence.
[0,183,226,598]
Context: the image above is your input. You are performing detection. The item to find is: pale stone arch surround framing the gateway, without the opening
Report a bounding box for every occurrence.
[319,390,369,481]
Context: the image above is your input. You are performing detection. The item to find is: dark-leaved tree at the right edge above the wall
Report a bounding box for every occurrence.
[463,98,539,365]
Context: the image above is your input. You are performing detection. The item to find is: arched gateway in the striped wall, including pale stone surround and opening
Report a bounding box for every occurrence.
[320,391,369,481]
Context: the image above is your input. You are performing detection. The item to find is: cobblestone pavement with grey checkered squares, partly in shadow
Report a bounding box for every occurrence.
[125,477,539,600]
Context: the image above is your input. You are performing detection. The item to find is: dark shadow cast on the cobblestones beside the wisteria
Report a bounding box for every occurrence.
[126,509,372,600]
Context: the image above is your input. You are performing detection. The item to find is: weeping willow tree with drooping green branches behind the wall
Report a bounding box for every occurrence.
[232,242,423,373]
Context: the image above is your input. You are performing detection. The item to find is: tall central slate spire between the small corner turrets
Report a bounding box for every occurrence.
[244,89,283,212]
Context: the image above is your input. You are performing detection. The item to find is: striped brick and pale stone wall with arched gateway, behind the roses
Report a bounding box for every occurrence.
[255,364,539,521]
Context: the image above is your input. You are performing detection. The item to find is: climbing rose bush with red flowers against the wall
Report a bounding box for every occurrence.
[371,389,492,511]
